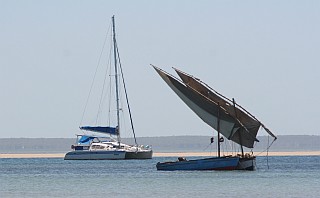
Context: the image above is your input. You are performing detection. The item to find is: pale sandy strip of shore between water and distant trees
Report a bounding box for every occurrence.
[0,151,320,158]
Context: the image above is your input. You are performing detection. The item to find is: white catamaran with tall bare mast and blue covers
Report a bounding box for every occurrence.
[64,16,153,160]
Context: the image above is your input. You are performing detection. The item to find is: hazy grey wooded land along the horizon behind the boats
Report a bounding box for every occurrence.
[0,135,320,153]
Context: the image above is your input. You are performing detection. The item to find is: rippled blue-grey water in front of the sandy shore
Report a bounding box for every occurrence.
[0,156,320,198]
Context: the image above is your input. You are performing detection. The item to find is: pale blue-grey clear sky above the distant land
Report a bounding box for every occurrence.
[0,0,320,138]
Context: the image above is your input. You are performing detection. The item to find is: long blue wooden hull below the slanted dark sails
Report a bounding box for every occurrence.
[157,157,239,171]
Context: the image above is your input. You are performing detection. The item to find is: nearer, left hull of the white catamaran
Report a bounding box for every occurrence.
[64,150,126,160]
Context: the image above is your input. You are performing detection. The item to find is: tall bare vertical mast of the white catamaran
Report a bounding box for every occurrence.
[112,15,121,146]
